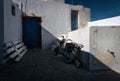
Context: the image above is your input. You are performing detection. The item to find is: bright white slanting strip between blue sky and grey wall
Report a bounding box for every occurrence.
[89,16,120,26]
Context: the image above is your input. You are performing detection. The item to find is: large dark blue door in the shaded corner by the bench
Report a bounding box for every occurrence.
[23,17,41,48]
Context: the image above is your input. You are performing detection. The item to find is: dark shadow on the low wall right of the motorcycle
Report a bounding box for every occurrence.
[80,51,117,71]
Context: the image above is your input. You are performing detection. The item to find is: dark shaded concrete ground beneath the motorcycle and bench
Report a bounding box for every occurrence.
[0,50,120,81]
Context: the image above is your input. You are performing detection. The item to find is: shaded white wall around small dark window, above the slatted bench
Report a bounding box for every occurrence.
[4,0,22,42]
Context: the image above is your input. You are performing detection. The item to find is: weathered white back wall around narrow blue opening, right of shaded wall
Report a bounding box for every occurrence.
[13,0,90,48]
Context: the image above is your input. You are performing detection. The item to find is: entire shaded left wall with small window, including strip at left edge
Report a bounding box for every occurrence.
[0,0,22,63]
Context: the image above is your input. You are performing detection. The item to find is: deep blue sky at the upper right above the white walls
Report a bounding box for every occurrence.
[65,0,120,21]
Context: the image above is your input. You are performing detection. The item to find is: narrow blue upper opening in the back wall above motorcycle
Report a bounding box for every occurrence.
[71,10,78,31]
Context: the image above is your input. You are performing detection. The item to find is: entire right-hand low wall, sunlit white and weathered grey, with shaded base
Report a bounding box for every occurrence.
[68,16,120,72]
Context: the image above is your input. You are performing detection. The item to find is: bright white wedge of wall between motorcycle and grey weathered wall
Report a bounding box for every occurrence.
[68,27,90,52]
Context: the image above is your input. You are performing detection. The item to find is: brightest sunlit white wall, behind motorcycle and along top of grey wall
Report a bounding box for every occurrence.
[68,16,120,52]
